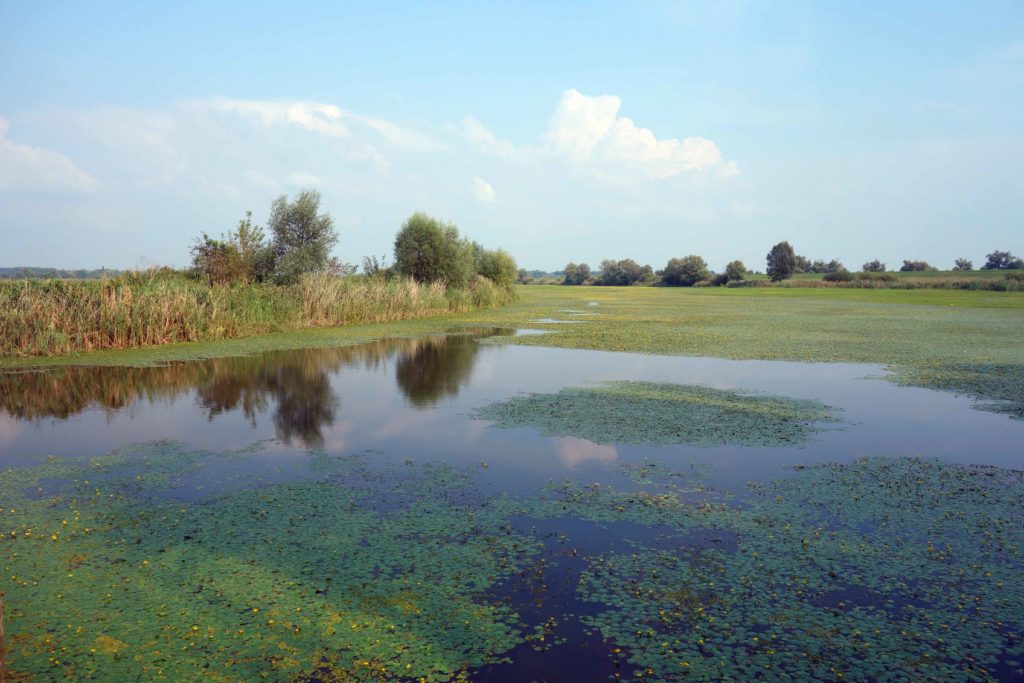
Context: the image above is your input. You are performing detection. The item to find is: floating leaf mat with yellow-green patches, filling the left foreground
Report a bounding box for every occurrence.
[0,443,536,681]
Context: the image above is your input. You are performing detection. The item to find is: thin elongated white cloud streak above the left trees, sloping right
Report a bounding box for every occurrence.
[196,97,444,152]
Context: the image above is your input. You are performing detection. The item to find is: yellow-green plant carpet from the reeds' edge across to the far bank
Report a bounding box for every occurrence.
[0,287,1024,417]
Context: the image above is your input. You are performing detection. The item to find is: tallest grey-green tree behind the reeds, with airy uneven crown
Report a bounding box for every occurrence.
[269,189,338,284]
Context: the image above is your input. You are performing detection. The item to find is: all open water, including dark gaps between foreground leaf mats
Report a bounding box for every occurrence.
[0,329,1024,681]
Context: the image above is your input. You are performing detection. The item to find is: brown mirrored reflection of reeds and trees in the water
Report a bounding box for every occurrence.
[0,329,513,447]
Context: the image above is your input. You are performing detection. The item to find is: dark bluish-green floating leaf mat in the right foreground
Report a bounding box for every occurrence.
[539,458,1024,681]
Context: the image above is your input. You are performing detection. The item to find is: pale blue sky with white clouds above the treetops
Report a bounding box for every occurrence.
[0,0,1024,270]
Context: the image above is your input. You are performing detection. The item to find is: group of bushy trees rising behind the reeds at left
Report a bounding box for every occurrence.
[190,189,517,289]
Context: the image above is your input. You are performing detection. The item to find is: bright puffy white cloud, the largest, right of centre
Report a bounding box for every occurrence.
[461,89,739,180]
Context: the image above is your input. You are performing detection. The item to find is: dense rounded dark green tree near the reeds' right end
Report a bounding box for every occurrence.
[394,212,476,289]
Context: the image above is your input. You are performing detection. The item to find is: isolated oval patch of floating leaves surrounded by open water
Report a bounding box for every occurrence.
[475,382,837,446]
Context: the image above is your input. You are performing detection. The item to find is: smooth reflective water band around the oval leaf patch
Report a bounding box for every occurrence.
[0,330,1024,490]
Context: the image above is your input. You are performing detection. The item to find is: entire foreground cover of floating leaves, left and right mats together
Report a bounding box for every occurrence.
[0,442,1024,681]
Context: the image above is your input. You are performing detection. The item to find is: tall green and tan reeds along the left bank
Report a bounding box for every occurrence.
[0,270,515,355]
